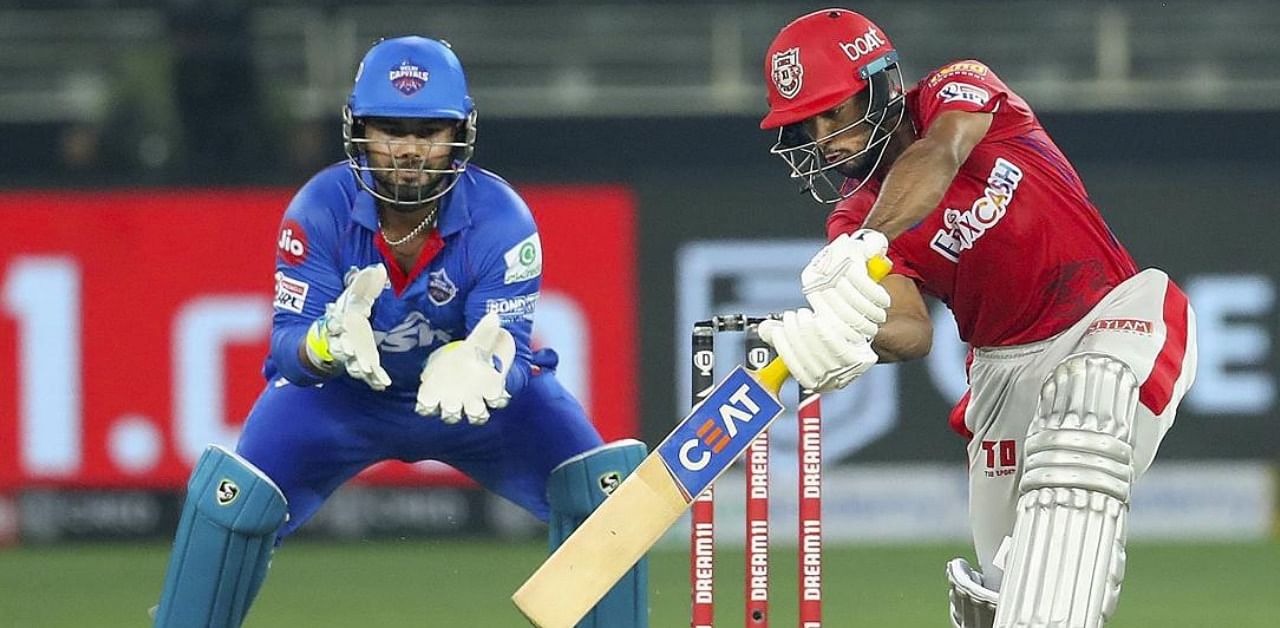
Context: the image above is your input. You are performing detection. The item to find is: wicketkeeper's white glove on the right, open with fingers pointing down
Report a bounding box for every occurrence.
[415,312,516,425]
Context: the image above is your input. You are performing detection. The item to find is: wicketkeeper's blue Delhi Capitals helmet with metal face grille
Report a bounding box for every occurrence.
[342,36,476,206]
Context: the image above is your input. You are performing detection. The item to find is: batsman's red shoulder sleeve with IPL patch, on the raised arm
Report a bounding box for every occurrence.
[916,59,1010,134]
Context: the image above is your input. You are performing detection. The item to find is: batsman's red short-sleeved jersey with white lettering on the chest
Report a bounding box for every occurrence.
[827,60,1137,347]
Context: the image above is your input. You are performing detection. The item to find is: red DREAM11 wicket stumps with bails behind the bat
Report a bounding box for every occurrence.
[689,315,822,628]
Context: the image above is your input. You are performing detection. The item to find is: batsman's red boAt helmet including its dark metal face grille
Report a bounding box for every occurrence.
[760,9,905,202]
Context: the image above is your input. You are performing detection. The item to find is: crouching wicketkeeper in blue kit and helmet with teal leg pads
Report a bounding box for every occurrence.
[155,37,648,628]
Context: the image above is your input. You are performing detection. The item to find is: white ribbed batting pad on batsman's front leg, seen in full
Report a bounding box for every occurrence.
[995,353,1138,628]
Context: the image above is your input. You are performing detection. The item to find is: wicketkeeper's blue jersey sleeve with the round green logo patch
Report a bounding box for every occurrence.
[465,192,543,396]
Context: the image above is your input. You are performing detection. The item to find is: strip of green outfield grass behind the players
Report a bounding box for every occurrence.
[0,541,1280,628]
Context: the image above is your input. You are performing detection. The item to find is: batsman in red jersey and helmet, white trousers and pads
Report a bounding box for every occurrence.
[760,9,1196,628]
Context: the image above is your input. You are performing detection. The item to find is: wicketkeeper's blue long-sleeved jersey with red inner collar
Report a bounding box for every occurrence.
[264,162,543,396]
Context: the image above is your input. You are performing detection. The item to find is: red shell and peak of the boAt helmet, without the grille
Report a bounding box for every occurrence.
[760,9,897,129]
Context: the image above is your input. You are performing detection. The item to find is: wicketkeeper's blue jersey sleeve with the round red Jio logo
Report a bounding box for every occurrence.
[270,188,344,386]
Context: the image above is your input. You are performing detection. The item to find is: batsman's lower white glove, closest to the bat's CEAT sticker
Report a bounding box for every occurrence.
[759,307,879,393]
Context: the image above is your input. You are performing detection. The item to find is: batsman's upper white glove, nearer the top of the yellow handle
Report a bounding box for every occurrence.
[800,229,890,339]
